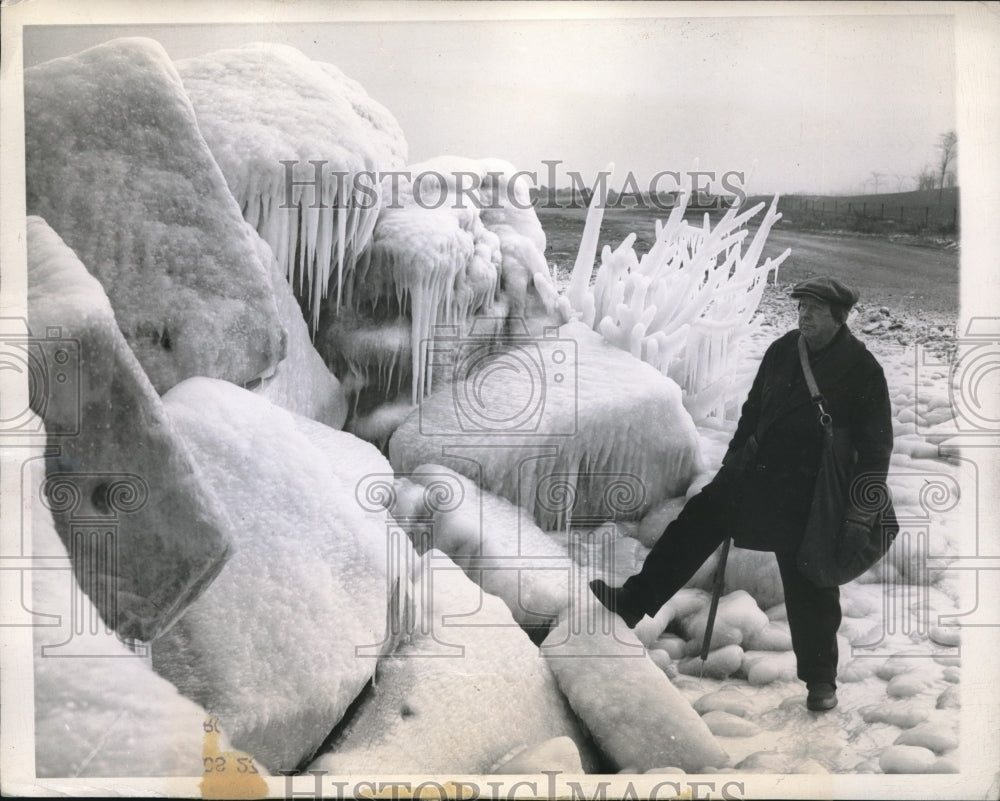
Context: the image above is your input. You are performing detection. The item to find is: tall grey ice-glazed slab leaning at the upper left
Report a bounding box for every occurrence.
[24,39,285,393]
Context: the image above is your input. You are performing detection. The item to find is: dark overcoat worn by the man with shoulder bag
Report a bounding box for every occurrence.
[720,325,895,551]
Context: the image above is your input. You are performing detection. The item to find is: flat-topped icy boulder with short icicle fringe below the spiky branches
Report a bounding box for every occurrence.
[389,323,701,530]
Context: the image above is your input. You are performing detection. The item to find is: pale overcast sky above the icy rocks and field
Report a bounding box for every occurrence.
[24,12,955,192]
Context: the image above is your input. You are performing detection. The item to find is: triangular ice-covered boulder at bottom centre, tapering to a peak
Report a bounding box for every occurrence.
[310,550,594,775]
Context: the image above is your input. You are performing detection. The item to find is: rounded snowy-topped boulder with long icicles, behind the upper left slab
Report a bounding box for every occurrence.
[177,43,407,331]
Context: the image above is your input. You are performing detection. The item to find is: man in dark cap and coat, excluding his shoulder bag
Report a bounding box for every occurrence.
[590,277,892,711]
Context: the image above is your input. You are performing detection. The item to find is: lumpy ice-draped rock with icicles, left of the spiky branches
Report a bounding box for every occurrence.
[328,156,565,414]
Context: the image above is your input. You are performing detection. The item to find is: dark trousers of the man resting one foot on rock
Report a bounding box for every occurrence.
[624,472,841,683]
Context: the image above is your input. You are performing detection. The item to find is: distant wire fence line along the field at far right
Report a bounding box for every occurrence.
[779,197,959,233]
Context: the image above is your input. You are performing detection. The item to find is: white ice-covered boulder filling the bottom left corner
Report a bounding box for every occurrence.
[30,471,234,778]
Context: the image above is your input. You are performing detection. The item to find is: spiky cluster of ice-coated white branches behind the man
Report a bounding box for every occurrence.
[566,188,790,420]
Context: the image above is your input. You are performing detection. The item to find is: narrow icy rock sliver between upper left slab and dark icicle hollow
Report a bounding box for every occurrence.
[253,234,347,428]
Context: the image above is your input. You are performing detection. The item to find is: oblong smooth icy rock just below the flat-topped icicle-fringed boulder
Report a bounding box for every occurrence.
[408,465,574,626]
